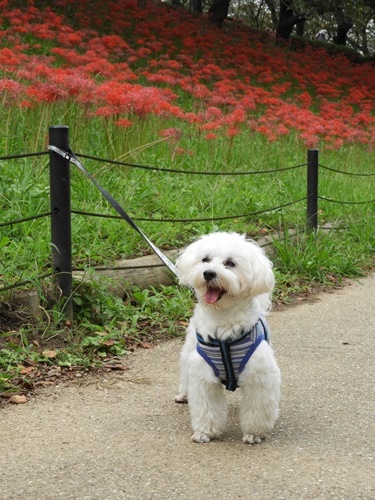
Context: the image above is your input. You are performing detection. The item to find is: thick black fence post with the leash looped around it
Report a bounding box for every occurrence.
[49,126,73,321]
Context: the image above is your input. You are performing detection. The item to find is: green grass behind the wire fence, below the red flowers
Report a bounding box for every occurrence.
[0,120,374,296]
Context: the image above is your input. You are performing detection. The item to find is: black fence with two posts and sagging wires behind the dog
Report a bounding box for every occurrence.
[0,126,375,316]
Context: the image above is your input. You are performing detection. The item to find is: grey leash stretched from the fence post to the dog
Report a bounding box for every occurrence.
[48,145,178,277]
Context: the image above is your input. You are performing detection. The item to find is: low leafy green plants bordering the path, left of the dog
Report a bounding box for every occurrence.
[0,280,192,394]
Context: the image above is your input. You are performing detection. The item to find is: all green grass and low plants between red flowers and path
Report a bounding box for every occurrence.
[0,123,374,393]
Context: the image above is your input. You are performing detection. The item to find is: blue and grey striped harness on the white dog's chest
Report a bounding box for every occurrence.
[197,318,269,392]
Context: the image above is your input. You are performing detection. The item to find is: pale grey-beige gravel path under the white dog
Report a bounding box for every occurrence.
[0,275,375,500]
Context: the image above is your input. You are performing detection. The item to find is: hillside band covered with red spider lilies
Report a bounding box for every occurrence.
[0,0,375,151]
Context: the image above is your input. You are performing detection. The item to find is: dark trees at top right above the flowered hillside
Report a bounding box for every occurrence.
[171,0,375,57]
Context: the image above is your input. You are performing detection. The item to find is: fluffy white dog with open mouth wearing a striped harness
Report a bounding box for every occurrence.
[175,232,281,444]
